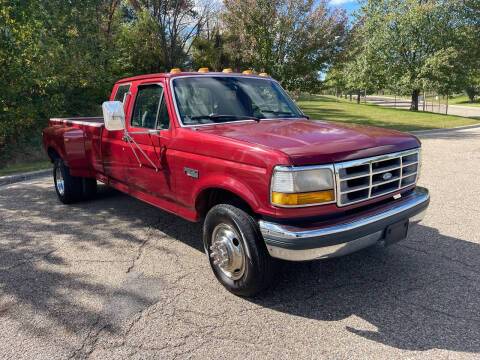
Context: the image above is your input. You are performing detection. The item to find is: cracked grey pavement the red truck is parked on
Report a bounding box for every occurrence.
[0,129,480,359]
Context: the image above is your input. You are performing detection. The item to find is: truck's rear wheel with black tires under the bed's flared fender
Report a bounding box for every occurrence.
[53,158,83,204]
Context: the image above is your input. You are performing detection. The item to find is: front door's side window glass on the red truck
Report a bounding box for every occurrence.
[131,84,163,129]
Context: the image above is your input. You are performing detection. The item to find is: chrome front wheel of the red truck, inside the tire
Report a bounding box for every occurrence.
[210,223,245,280]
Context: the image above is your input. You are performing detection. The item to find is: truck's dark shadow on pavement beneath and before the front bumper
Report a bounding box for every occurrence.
[252,225,480,353]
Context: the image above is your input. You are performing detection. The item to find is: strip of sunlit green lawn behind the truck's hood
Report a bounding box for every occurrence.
[297,95,480,131]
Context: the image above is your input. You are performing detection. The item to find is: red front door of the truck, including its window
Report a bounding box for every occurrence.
[127,81,174,200]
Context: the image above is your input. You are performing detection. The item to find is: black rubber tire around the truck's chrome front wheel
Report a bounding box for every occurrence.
[203,204,275,296]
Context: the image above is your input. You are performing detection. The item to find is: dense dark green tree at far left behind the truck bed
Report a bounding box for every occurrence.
[0,0,118,164]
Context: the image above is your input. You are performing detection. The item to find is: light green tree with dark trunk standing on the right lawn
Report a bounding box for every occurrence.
[359,0,474,110]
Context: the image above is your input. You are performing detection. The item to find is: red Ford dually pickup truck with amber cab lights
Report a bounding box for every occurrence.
[43,70,429,296]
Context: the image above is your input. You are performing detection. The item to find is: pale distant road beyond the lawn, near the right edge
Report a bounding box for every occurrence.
[367,95,480,119]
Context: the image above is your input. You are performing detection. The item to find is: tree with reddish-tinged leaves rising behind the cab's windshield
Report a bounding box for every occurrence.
[223,0,347,90]
